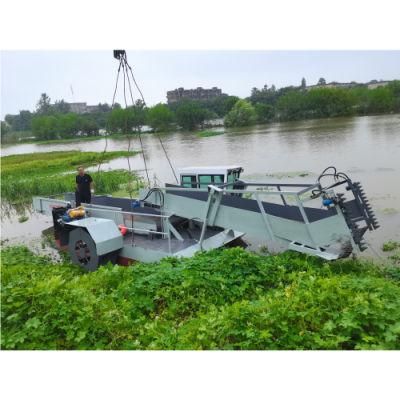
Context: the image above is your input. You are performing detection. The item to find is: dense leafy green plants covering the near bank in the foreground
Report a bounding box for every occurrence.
[1,247,400,349]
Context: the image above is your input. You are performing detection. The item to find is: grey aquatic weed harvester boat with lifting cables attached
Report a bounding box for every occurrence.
[33,51,379,271]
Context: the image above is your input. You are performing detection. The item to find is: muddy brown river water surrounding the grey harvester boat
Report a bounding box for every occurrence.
[2,114,400,258]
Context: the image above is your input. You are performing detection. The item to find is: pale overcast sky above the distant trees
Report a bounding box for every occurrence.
[1,50,400,119]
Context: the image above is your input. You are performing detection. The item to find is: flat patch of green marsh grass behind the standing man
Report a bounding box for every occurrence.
[1,151,136,203]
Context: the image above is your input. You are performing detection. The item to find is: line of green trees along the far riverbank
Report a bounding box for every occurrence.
[1,78,400,142]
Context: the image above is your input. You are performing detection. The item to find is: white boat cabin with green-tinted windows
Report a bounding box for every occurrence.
[178,165,243,189]
